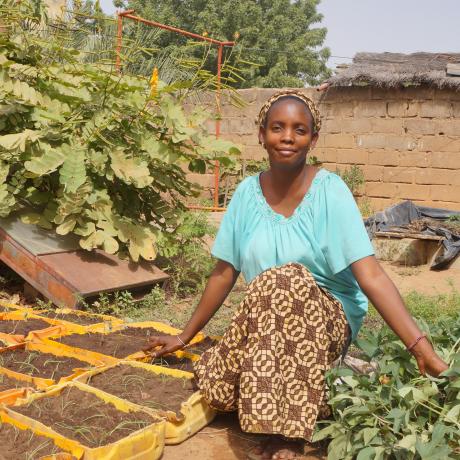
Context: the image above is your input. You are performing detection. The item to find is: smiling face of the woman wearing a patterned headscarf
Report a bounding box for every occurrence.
[259,99,318,169]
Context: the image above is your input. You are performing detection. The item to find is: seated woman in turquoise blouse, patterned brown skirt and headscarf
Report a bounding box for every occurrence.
[149,90,447,459]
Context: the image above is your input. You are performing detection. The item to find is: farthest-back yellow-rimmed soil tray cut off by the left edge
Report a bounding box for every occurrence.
[0,310,65,345]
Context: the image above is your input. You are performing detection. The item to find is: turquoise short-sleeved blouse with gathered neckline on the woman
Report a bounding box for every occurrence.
[212,169,374,338]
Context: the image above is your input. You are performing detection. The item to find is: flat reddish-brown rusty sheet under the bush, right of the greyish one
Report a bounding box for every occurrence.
[38,250,168,297]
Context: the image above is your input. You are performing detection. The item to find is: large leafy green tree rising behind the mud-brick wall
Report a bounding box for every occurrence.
[122,0,330,88]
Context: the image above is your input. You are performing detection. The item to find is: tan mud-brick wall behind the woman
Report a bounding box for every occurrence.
[196,87,460,210]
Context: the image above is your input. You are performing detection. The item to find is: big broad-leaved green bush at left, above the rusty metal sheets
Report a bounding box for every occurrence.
[0,0,238,261]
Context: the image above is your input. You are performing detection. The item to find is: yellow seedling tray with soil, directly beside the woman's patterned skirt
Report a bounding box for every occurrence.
[76,361,215,444]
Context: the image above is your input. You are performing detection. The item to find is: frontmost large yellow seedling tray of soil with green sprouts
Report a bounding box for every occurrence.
[1,382,165,460]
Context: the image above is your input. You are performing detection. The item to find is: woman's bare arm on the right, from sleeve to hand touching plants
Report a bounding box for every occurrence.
[351,256,448,376]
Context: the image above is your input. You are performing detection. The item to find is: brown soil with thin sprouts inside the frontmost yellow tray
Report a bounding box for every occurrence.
[14,388,156,447]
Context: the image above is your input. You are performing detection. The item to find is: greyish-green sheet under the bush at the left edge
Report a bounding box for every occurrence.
[0,216,80,256]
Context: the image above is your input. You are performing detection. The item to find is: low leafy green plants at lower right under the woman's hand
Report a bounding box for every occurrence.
[313,314,460,460]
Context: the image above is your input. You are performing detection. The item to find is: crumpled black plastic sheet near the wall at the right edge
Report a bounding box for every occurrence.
[364,201,460,270]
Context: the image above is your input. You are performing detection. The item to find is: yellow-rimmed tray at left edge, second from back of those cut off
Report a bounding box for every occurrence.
[0,342,106,389]
